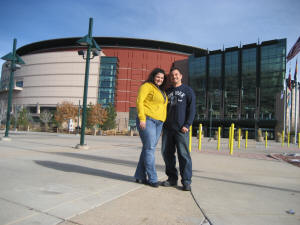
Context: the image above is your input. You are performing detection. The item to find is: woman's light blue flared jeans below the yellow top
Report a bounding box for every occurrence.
[134,117,163,183]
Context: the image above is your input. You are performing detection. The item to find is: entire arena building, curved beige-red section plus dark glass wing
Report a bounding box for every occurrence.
[0,37,300,138]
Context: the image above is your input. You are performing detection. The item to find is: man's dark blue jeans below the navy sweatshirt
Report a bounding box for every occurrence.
[161,128,192,185]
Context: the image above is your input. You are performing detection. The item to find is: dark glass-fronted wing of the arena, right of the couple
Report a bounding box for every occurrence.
[188,39,299,137]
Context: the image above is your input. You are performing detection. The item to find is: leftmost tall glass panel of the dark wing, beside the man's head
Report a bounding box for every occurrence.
[189,56,206,120]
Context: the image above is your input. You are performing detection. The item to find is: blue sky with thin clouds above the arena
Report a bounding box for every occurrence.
[0,0,300,75]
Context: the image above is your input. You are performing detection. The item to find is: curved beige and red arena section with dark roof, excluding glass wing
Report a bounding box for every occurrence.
[0,37,206,129]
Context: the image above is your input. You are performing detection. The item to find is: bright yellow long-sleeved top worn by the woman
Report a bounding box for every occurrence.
[136,82,168,122]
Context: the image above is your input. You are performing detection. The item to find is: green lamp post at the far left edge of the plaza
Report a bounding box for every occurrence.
[1,39,25,140]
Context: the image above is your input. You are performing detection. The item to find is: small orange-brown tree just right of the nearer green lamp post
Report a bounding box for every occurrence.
[87,103,107,132]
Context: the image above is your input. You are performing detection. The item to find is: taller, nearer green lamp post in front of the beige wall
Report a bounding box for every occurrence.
[76,18,101,148]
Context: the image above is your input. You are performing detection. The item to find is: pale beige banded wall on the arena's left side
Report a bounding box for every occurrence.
[2,51,100,107]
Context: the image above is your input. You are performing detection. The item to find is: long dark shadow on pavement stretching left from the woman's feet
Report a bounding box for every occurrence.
[34,160,134,182]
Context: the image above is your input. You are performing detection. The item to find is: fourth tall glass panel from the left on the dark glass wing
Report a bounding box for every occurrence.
[241,47,257,119]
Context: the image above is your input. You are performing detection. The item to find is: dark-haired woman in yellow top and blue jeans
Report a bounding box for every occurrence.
[134,68,168,187]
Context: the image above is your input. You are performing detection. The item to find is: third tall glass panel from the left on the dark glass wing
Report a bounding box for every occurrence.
[224,51,239,119]
